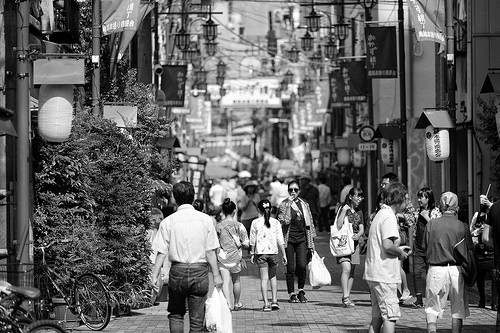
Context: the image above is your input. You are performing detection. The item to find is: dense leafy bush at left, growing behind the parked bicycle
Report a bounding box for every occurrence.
[33,70,172,305]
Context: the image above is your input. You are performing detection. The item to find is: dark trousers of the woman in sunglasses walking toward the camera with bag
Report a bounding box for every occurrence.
[285,241,307,294]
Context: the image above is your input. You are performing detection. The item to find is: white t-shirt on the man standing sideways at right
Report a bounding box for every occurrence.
[363,205,401,283]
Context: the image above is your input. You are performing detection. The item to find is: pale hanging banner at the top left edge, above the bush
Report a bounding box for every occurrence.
[101,0,140,35]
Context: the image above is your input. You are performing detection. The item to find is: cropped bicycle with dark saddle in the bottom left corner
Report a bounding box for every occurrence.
[0,281,66,333]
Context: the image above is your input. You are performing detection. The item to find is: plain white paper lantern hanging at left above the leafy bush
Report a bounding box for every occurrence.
[38,84,73,142]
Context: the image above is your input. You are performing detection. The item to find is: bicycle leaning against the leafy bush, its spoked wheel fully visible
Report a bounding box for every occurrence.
[35,241,111,331]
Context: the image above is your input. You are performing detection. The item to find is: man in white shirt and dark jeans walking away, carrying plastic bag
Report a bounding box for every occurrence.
[152,181,222,333]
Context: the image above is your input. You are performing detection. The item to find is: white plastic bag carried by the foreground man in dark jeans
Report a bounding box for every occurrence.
[205,288,233,333]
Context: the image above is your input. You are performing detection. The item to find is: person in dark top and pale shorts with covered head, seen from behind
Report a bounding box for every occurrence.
[423,192,473,333]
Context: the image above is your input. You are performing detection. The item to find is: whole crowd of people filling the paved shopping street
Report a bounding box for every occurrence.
[147,171,497,333]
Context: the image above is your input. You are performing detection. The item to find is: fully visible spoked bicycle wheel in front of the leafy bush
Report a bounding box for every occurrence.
[74,273,111,331]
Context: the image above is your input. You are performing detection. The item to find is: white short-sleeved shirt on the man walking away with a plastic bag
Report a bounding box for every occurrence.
[153,205,219,264]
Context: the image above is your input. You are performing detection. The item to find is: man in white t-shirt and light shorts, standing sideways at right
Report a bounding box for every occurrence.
[363,183,411,333]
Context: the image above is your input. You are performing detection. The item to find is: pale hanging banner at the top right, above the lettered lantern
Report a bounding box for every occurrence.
[408,0,446,46]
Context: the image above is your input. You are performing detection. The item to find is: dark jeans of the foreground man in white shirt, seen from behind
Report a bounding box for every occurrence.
[167,263,208,333]
